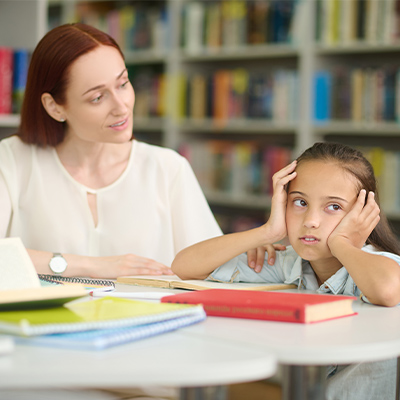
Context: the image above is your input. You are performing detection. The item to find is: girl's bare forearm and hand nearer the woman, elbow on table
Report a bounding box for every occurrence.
[172,162,296,279]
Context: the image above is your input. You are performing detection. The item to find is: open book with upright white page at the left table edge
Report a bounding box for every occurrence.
[0,238,87,310]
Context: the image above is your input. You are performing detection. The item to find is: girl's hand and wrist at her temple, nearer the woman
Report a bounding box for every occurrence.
[264,160,297,243]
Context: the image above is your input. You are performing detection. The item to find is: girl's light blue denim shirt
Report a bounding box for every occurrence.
[207,245,400,302]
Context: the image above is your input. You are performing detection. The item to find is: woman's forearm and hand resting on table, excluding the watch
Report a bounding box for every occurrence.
[28,249,172,279]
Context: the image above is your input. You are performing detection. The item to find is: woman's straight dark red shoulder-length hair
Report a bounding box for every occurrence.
[18,23,124,146]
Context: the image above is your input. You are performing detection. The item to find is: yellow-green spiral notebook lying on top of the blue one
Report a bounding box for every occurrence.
[0,297,204,336]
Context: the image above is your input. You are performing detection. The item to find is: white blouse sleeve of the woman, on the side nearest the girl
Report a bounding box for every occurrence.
[170,157,222,253]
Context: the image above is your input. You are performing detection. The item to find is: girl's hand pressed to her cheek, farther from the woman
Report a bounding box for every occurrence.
[328,189,380,255]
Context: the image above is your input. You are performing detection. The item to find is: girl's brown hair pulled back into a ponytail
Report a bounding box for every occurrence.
[297,142,400,255]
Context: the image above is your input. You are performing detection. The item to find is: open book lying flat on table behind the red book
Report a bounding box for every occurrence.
[117,275,297,291]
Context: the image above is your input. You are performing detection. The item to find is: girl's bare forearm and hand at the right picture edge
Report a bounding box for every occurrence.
[328,190,400,306]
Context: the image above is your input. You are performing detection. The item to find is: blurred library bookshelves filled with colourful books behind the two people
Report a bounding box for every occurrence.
[0,0,400,235]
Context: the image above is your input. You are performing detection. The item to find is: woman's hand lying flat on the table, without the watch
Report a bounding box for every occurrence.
[89,254,173,279]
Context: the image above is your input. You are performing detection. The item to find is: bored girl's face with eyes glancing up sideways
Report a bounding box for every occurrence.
[286,161,358,262]
